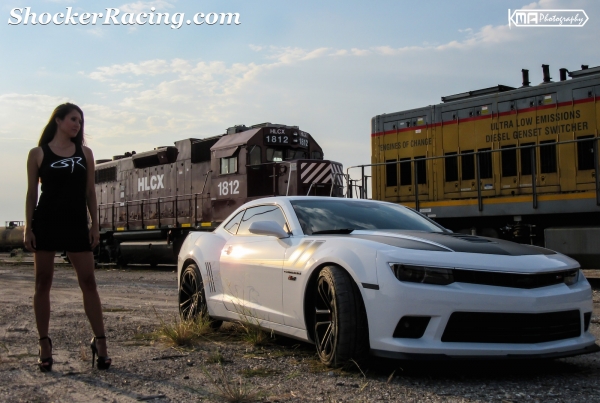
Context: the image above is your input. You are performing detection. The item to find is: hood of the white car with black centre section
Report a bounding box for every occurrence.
[345,230,556,256]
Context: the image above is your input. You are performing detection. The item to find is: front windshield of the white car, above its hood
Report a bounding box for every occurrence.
[291,199,444,235]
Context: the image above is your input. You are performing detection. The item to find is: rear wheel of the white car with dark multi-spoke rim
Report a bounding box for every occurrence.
[179,264,223,330]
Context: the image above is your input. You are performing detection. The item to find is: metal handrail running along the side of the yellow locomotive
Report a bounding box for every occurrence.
[346,137,600,211]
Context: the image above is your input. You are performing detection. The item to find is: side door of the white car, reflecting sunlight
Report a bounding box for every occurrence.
[220,204,289,323]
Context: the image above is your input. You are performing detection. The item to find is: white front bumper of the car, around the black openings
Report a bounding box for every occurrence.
[363,256,600,359]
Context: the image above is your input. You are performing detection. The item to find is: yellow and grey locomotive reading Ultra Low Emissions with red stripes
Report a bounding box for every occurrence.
[361,65,600,269]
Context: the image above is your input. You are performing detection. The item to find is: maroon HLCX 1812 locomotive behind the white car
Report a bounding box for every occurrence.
[96,123,344,265]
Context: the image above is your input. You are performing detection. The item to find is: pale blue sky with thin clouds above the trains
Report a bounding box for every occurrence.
[0,0,600,223]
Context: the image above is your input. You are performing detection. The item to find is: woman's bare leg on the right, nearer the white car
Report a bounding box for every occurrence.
[67,252,108,357]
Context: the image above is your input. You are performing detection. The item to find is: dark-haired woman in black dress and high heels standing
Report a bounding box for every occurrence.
[24,103,111,372]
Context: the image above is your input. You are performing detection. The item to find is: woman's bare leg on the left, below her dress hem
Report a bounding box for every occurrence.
[33,251,54,358]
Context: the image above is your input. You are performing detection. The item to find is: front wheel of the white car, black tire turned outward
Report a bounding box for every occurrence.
[313,266,369,367]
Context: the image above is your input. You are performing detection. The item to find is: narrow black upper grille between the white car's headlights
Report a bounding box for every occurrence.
[453,269,576,289]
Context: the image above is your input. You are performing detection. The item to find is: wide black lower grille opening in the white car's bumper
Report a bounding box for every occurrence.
[442,310,581,343]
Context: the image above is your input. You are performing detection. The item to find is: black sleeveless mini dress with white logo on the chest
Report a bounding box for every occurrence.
[31,144,92,252]
